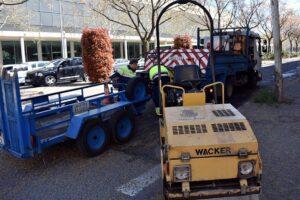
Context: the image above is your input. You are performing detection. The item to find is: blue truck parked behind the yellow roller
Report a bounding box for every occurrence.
[198,27,262,97]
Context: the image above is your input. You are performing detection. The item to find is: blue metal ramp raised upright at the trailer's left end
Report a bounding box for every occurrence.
[0,71,31,157]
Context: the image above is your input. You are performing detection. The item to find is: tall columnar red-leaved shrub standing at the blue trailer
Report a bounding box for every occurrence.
[81,28,114,83]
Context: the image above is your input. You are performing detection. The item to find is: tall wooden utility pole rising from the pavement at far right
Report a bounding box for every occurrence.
[271,0,283,102]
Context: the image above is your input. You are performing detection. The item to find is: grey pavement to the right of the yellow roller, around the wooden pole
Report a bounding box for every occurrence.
[239,77,300,200]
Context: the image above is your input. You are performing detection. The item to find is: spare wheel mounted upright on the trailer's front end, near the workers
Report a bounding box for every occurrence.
[125,77,147,100]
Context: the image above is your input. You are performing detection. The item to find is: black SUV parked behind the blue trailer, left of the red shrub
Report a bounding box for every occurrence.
[26,57,87,87]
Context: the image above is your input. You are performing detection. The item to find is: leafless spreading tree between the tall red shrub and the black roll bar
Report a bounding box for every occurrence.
[87,0,175,56]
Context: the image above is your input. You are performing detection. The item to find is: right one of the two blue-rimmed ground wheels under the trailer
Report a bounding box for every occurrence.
[111,111,135,144]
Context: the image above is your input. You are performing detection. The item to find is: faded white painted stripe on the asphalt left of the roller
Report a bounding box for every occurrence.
[117,165,161,197]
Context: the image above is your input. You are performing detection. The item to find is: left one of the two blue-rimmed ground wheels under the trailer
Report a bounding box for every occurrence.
[77,120,109,157]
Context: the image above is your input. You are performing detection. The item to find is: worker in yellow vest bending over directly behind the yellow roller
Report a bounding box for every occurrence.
[149,65,172,115]
